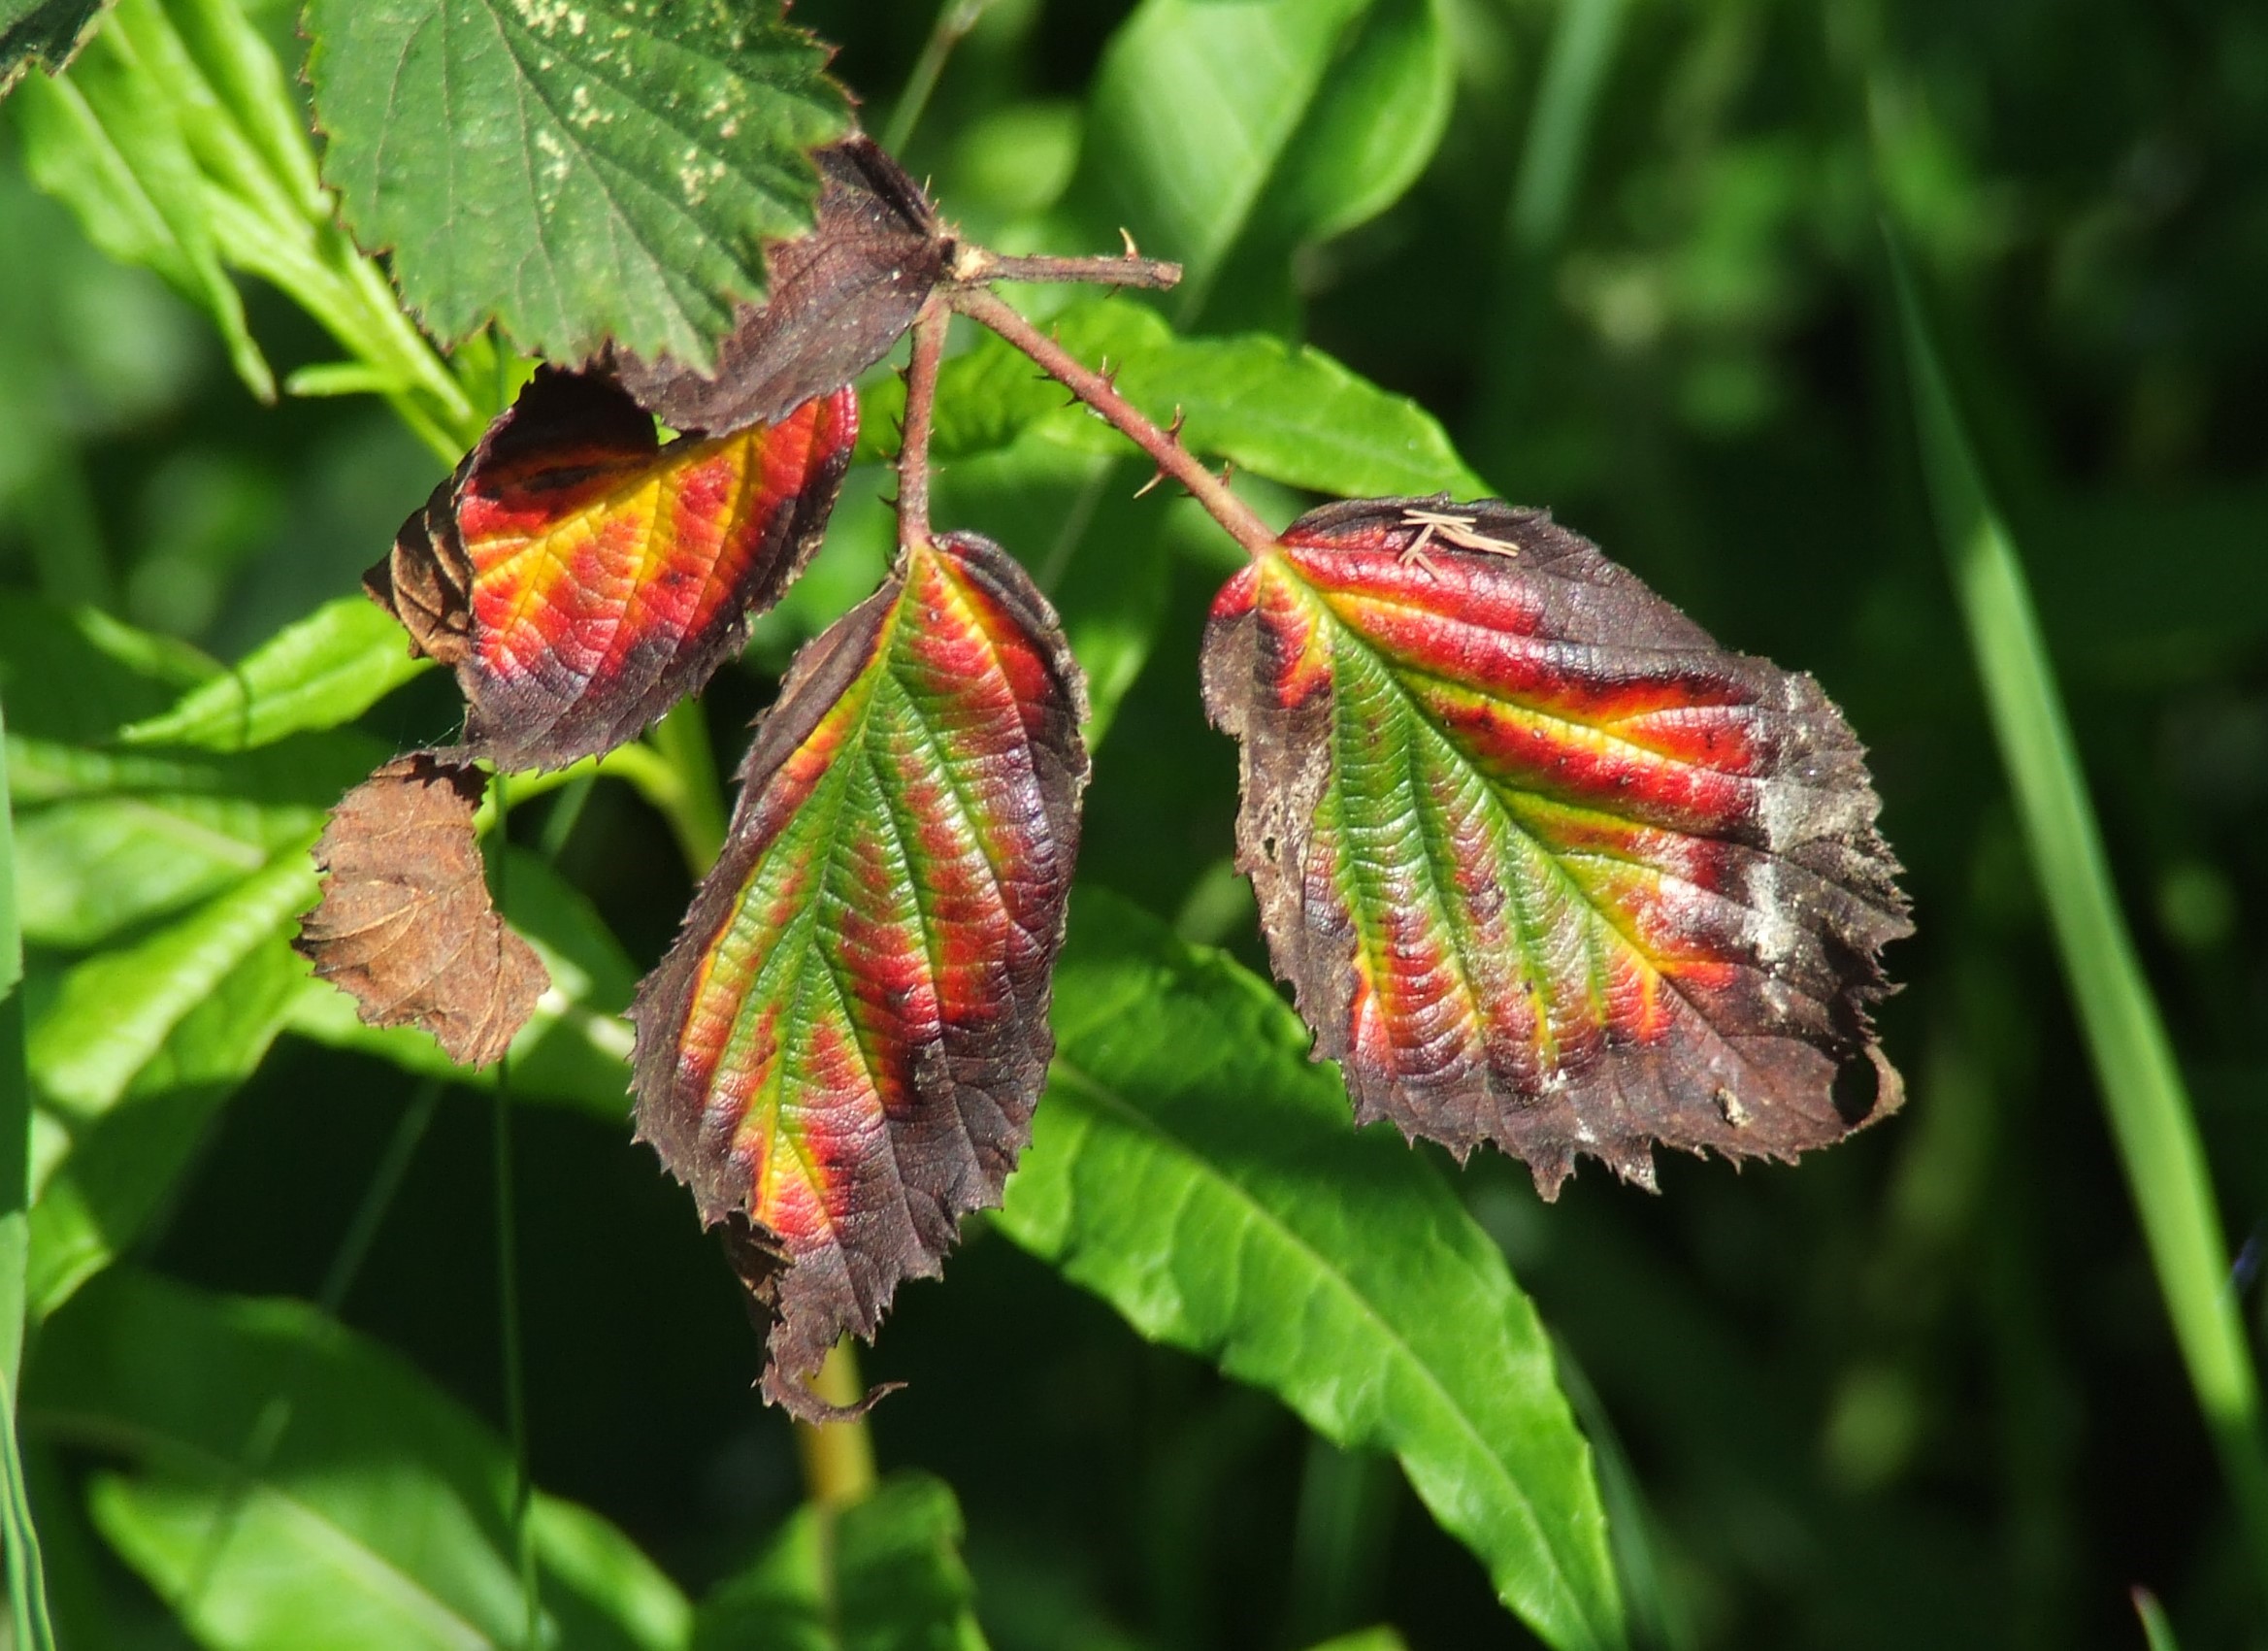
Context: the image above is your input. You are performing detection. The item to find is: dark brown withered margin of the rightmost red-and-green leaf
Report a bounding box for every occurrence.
[1202,494,1912,1198]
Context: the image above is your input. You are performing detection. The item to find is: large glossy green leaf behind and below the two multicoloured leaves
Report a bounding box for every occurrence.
[998,889,1624,1646]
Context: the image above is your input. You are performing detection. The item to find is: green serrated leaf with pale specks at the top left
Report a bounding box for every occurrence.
[306,0,850,368]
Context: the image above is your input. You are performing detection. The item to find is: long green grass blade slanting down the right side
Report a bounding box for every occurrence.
[1883,232,2268,1588]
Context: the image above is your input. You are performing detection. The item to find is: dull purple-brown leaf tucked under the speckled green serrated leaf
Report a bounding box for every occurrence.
[594,136,953,433]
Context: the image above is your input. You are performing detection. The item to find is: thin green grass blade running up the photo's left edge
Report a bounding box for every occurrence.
[0,698,54,1651]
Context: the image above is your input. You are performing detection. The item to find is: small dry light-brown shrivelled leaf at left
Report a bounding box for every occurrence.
[292,750,551,1066]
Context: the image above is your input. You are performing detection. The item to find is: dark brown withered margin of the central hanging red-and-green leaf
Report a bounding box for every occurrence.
[631,533,1089,1420]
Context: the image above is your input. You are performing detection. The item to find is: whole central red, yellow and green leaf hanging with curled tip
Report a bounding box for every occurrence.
[633,533,1086,1417]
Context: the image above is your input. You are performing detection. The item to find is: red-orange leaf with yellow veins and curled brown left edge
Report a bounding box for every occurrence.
[365,368,857,769]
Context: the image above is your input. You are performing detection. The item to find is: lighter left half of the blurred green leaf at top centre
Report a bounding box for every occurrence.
[1068,0,1367,315]
